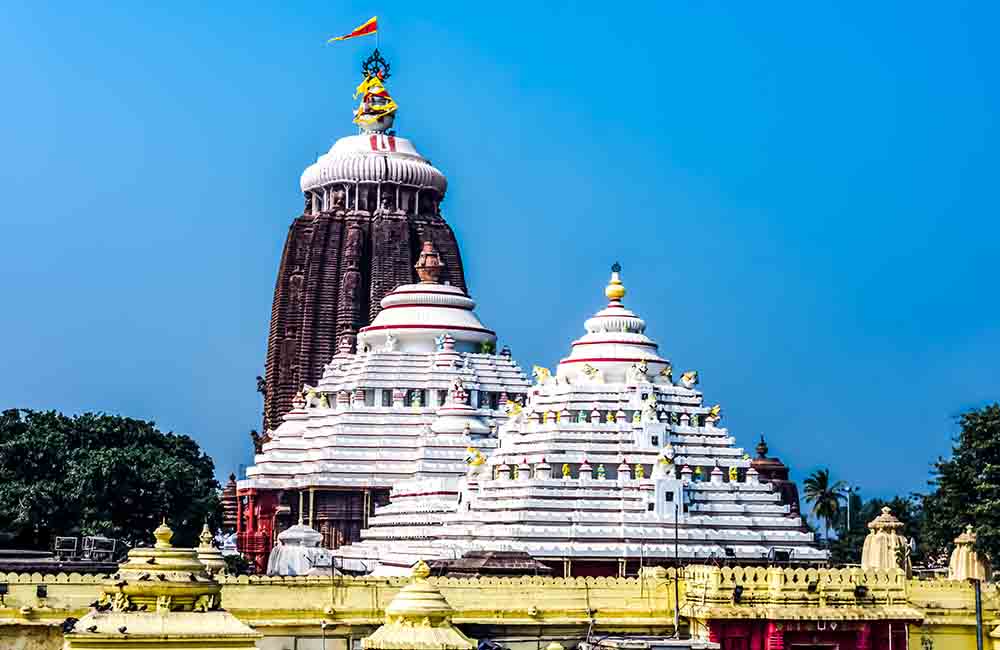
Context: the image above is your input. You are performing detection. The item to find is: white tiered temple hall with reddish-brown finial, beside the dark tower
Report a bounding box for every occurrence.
[236,242,530,570]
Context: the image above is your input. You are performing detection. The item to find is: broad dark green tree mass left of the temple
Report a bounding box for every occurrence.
[0,409,221,548]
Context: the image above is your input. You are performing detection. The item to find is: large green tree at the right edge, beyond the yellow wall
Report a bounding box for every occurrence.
[921,403,1000,563]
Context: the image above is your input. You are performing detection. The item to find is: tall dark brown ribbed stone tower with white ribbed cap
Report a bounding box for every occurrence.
[264,50,465,431]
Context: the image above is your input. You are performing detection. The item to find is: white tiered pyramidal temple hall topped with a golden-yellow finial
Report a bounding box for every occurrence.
[340,264,827,576]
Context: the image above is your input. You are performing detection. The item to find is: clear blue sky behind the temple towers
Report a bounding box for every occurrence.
[0,1,1000,496]
